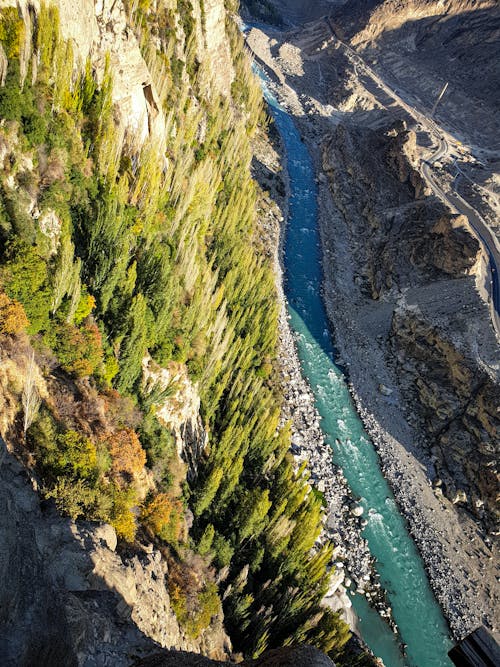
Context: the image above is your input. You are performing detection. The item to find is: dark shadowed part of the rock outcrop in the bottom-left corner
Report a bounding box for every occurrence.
[0,438,224,667]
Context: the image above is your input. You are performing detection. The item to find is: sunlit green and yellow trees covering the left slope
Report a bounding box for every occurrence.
[0,0,348,655]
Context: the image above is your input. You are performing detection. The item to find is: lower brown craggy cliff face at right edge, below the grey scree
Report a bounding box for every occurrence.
[390,309,500,531]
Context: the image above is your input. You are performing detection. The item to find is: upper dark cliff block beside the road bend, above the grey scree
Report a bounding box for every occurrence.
[323,124,480,298]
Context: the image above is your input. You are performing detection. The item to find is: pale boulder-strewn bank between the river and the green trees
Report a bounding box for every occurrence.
[250,73,395,631]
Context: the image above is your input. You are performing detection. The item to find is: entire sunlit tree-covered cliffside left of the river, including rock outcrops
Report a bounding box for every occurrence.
[0,0,356,664]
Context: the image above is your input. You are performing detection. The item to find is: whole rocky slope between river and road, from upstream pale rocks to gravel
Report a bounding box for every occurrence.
[244,3,499,637]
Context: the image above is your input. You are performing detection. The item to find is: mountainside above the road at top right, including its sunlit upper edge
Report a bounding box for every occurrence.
[332,0,500,148]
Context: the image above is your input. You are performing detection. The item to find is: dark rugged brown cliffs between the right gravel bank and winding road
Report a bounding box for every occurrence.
[323,117,500,530]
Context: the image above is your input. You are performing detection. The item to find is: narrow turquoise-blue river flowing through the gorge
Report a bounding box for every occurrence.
[259,72,452,667]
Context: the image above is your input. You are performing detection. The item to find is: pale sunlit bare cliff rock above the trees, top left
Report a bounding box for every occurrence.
[0,0,234,146]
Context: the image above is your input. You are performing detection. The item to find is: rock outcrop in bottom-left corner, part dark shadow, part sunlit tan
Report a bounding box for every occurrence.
[0,440,231,667]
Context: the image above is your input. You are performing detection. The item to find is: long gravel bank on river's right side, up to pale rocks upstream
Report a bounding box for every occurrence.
[249,18,498,638]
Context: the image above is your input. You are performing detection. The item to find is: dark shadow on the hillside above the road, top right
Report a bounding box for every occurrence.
[333,3,500,149]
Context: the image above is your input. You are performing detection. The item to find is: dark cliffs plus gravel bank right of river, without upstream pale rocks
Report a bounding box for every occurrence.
[322,115,499,635]
